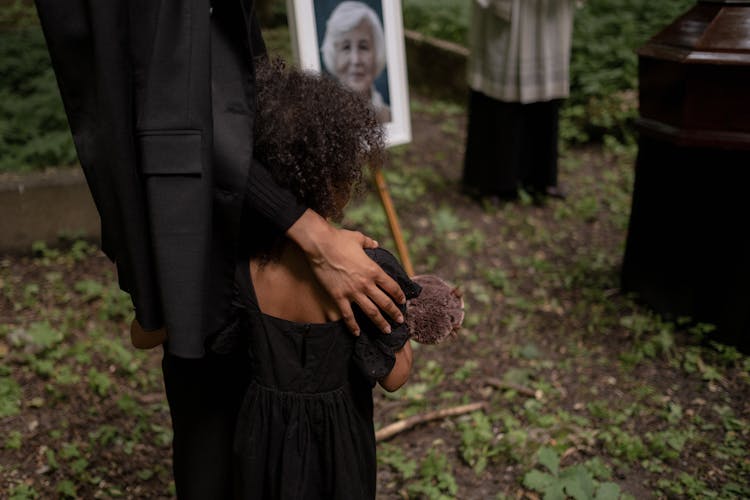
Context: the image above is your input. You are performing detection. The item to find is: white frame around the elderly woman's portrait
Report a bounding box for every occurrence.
[287,0,418,147]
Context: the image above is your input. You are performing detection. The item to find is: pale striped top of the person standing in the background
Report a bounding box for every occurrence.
[468,0,575,103]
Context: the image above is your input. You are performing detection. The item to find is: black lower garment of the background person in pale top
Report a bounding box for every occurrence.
[462,90,561,198]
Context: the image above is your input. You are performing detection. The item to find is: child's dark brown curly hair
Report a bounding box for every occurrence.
[254,59,385,219]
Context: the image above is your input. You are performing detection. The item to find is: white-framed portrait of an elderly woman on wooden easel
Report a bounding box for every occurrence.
[287,0,418,147]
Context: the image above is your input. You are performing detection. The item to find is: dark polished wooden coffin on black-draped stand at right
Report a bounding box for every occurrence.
[622,1,750,350]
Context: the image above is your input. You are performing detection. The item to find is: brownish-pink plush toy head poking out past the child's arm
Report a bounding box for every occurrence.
[406,274,464,344]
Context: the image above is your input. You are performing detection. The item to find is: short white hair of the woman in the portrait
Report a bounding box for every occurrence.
[320,1,385,75]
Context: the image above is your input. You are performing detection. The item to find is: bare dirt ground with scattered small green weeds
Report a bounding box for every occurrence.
[0,96,750,499]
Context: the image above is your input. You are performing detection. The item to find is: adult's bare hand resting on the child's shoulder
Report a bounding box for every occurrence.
[287,209,406,335]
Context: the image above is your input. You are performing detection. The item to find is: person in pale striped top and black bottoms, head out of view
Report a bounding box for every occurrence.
[462,0,575,199]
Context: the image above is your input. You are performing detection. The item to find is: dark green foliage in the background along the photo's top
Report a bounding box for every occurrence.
[0,0,695,172]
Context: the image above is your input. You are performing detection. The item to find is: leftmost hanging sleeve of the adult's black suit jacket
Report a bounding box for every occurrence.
[35,0,165,330]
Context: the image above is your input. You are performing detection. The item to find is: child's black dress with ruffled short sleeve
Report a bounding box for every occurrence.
[235,249,420,500]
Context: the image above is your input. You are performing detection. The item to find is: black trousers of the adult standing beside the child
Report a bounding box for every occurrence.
[162,350,250,500]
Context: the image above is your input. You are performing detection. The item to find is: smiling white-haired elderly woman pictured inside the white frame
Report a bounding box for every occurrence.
[320,1,391,123]
